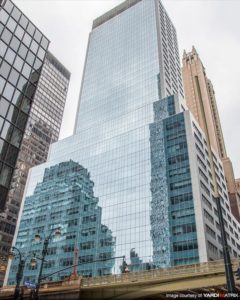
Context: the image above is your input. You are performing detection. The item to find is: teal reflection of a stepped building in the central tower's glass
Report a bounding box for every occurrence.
[9,160,115,284]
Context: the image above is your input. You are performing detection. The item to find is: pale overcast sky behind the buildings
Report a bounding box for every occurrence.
[13,0,240,178]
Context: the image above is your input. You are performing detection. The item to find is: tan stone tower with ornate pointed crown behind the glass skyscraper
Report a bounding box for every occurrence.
[182,47,240,221]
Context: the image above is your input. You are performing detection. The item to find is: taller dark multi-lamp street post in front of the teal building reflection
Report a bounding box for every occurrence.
[31,227,61,300]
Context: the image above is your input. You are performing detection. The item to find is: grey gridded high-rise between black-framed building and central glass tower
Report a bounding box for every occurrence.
[0,51,70,284]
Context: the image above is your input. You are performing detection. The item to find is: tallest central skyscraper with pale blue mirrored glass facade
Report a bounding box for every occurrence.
[6,0,240,284]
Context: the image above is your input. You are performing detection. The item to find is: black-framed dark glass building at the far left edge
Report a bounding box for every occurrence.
[0,0,49,213]
